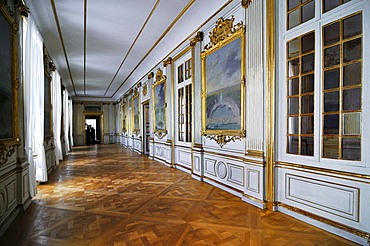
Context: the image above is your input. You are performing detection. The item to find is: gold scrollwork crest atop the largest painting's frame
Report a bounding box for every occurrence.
[204,16,244,50]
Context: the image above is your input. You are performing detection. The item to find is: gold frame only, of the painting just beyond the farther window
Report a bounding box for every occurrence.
[152,69,167,138]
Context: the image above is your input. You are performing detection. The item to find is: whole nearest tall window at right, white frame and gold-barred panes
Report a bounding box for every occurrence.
[278,0,364,165]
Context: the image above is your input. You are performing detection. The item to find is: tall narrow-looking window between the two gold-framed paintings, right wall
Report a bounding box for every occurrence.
[177,59,193,143]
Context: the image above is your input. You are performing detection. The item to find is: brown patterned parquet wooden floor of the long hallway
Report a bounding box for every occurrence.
[0,145,356,246]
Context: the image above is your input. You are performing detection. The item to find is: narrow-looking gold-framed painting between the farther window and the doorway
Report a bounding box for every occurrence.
[153,69,167,138]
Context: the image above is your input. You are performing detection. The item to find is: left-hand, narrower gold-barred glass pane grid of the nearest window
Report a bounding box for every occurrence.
[286,32,315,156]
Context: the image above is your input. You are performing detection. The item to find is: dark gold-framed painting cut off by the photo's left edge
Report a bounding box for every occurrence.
[0,3,20,146]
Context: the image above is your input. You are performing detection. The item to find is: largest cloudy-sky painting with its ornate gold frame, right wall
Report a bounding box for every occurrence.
[201,18,245,147]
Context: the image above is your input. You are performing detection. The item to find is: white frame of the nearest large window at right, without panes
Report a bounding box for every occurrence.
[276,0,370,174]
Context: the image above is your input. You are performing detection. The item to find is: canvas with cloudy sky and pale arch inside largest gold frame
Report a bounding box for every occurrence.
[205,37,242,130]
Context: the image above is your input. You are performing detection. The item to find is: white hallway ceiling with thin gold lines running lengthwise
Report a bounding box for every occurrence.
[25,0,230,101]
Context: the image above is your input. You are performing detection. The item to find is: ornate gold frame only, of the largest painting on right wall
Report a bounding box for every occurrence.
[201,18,246,147]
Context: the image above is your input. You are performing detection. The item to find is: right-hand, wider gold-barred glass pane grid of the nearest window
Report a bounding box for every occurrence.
[322,13,362,161]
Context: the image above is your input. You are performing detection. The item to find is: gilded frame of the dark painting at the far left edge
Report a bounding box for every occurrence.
[0,2,20,148]
